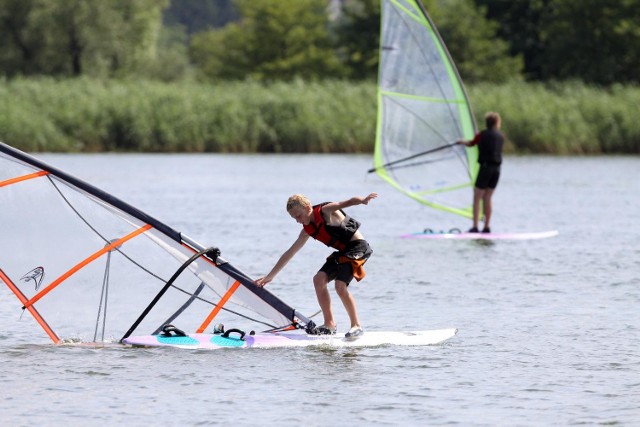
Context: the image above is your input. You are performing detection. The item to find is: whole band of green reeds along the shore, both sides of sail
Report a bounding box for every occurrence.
[0,79,640,154]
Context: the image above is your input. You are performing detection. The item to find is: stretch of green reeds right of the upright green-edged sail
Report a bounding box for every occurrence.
[469,82,640,155]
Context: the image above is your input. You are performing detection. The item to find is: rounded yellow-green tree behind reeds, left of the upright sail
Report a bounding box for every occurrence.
[190,0,342,80]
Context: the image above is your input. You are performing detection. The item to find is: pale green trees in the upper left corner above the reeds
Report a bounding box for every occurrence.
[0,0,168,76]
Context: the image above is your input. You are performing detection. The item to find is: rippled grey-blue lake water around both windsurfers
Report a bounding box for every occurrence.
[0,154,640,426]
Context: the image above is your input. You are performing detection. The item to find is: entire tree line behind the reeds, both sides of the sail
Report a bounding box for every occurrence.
[0,0,640,85]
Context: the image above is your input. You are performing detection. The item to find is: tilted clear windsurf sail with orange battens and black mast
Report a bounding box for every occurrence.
[0,143,311,343]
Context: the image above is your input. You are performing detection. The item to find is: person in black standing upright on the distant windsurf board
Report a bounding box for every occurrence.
[458,112,505,233]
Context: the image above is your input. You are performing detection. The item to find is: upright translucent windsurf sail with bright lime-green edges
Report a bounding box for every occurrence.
[369,0,478,217]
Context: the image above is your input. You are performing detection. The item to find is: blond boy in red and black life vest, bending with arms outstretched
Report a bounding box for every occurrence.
[256,193,378,339]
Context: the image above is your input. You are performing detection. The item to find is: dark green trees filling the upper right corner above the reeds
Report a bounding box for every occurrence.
[475,0,640,85]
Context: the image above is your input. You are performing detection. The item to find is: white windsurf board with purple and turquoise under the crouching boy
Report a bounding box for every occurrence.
[122,328,458,350]
